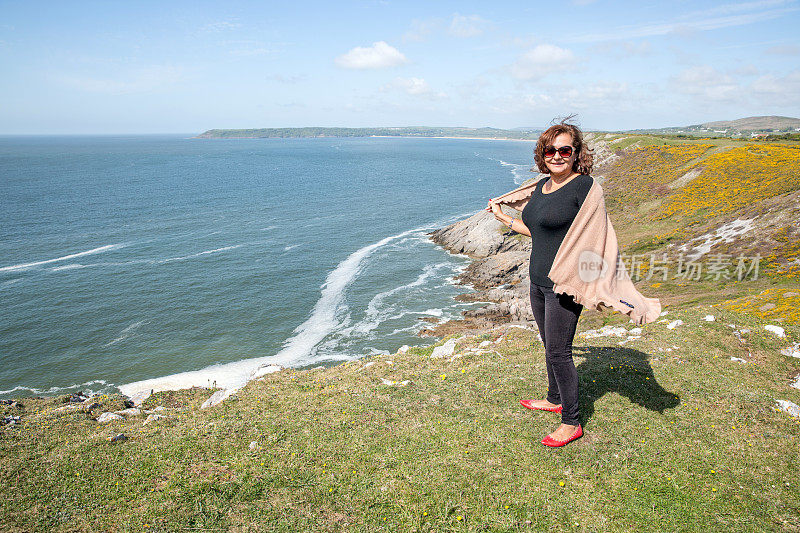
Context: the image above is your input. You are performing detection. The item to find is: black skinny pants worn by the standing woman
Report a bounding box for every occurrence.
[531,283,583,426]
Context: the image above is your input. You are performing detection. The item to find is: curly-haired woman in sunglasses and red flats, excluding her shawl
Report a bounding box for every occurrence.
[489,122,613,447]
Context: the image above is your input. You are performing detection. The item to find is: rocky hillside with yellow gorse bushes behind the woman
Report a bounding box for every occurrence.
[432,134,800,334]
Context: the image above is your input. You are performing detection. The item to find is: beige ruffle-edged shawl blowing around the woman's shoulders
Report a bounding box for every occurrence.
[492,180,661,324]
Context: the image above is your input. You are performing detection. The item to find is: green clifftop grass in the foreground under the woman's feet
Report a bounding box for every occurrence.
[0,294,800,531]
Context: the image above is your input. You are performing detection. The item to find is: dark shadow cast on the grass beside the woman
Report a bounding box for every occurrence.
[572,346,680,423]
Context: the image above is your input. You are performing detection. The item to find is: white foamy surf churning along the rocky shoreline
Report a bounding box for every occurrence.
[115,220,472,395]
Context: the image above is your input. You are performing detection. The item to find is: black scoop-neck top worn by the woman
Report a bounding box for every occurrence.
[522,174,594,288]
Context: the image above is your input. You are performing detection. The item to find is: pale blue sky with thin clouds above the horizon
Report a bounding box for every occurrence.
[0,0,800,134]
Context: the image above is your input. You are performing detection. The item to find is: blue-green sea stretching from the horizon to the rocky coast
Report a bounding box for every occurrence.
[0,135,535,398]
